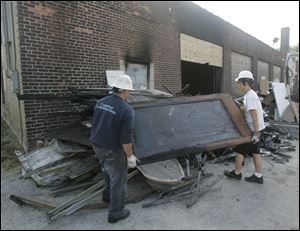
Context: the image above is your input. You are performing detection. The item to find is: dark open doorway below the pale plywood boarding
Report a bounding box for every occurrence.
[181,61,222,95]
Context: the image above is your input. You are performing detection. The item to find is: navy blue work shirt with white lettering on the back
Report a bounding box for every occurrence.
[90,94,134,150]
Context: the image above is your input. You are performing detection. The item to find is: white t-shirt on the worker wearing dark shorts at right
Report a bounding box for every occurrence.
[244,89,265,131]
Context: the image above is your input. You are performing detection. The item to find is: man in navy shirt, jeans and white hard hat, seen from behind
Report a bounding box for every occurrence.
[90,75,138,223]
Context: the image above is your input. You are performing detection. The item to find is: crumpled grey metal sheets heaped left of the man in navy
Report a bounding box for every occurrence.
[15,139,100,186]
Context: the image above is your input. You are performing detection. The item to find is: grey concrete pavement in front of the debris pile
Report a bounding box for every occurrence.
[1,140,299,230]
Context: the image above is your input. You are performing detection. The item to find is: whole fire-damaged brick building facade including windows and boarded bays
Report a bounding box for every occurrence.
[1,1,289,150]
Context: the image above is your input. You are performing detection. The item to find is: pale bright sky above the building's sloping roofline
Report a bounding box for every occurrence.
[193,1,299,49]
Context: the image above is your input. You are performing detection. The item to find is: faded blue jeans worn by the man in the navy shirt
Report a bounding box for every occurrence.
[93,145,127,218]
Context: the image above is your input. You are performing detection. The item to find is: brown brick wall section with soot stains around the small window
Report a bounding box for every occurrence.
[17,1,181,149]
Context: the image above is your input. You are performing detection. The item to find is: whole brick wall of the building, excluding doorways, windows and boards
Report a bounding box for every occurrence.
[16,1,284,149]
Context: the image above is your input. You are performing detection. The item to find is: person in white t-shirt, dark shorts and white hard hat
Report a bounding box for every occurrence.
[224,70,265,184]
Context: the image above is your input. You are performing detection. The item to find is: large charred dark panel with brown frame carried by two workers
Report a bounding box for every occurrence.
[133,94,251,164]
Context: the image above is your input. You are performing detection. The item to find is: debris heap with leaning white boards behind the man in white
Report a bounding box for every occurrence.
[261,82,299,163]
